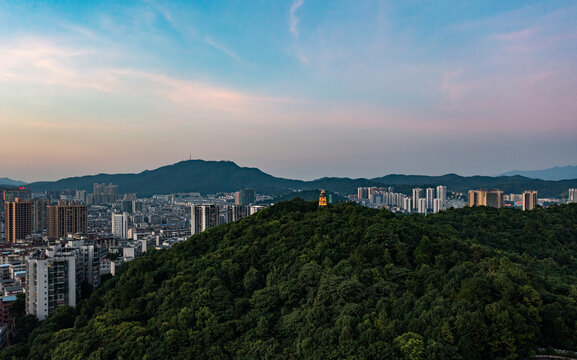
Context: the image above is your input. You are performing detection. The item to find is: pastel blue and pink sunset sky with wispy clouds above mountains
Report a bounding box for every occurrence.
[0,0,577,181]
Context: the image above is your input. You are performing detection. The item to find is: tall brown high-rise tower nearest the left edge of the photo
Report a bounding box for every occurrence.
[4,198,32,243]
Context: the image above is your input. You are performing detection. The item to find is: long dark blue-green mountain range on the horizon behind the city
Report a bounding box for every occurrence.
[28,160,577,197]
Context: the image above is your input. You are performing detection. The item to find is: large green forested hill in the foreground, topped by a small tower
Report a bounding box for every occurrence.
[0,200,577,359]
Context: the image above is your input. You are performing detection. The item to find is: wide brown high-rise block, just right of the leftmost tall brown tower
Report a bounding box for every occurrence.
[47,201,88,238]
